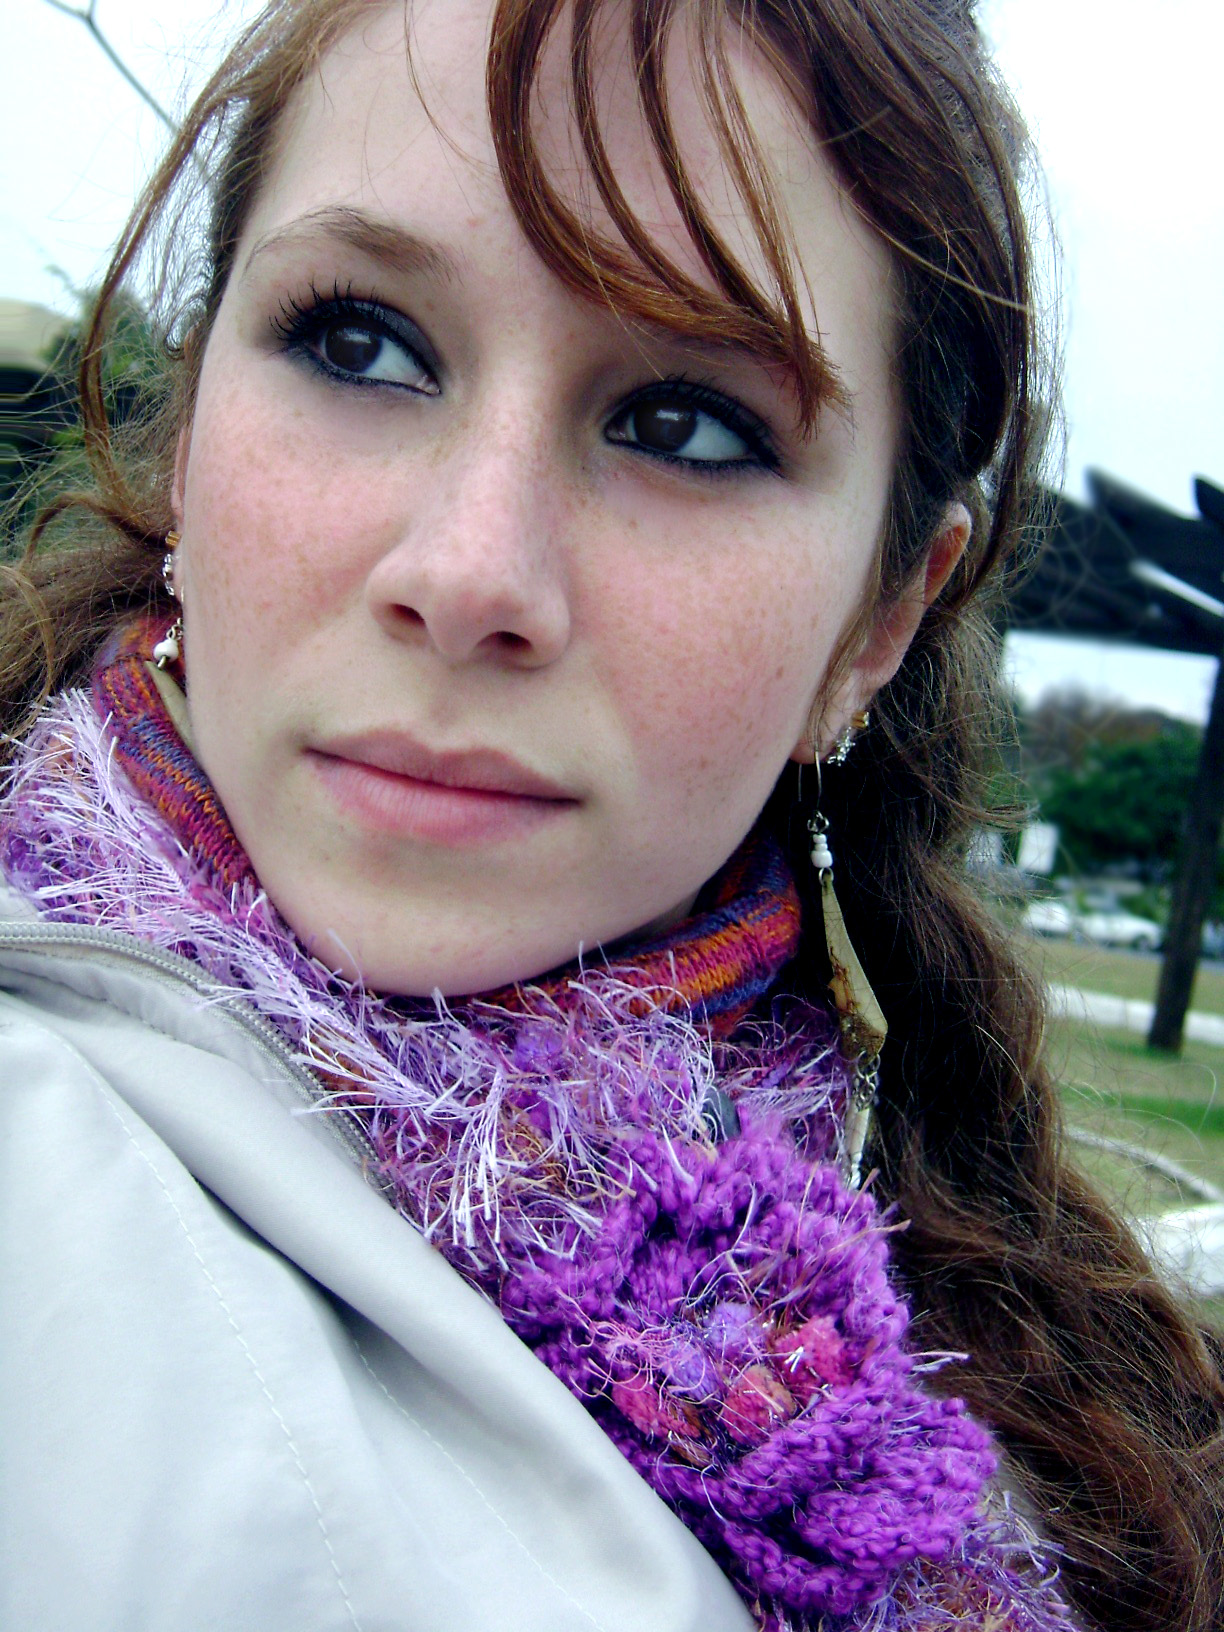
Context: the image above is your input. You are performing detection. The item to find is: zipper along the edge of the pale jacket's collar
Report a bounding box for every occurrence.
[0,919,384,1188]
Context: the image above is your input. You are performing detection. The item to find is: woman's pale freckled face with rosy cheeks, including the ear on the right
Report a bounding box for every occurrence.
[176,0,920,994]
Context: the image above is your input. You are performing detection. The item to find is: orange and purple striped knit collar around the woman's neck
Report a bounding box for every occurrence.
[93,619,800,1036]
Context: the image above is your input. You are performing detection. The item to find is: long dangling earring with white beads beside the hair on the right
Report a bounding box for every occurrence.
[808,734,888,1186]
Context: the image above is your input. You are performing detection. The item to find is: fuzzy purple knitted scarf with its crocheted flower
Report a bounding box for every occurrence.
[0,656,1072,1632]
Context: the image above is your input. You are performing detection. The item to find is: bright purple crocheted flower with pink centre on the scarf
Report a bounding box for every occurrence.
[499,1124,994,1617]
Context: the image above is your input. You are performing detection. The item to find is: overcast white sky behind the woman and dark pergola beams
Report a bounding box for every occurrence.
[0,0,1224,718]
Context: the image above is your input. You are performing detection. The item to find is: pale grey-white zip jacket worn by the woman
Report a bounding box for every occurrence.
[0,891,752,1632]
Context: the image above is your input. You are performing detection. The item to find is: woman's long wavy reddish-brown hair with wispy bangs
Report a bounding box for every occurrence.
[0,0,1224,1632]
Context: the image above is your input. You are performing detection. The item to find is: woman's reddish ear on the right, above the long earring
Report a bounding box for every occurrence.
[790,504,973,765]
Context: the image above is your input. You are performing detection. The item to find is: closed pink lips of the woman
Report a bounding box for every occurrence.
[308,731,578,845]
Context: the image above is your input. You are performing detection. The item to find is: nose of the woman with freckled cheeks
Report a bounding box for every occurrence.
[366,413,571,669]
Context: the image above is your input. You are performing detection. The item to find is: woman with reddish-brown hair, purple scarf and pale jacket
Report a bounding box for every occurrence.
[2,0,1224,1629]
